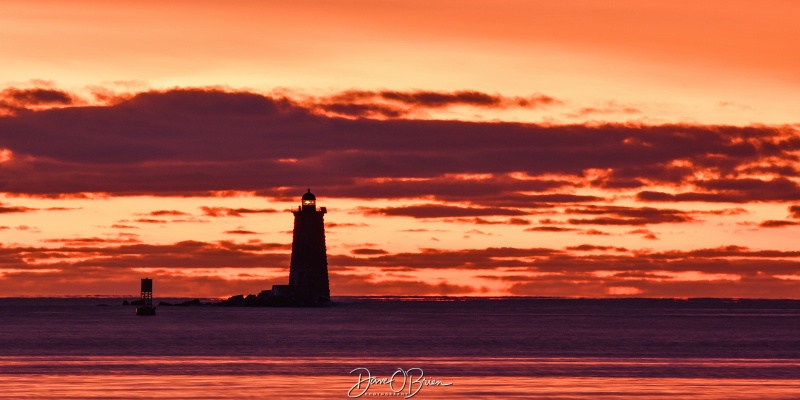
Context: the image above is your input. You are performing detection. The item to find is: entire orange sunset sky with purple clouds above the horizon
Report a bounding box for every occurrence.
[0,0,800,298]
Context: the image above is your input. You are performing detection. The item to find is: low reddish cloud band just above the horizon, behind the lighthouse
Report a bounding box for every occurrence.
[0,238,800,297]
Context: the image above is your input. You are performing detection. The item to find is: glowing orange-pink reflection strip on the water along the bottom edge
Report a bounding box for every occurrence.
[0,357,800,399]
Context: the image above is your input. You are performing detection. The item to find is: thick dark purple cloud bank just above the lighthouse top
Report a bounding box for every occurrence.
[0,89,800,206]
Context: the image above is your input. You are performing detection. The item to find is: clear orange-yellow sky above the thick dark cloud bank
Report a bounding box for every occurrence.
[0,1,800,124]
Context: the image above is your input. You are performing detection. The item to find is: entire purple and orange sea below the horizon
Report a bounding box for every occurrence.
[0,297,800,399]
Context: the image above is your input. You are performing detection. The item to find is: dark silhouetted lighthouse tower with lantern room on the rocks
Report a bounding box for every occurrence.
[289,189,331,305]
